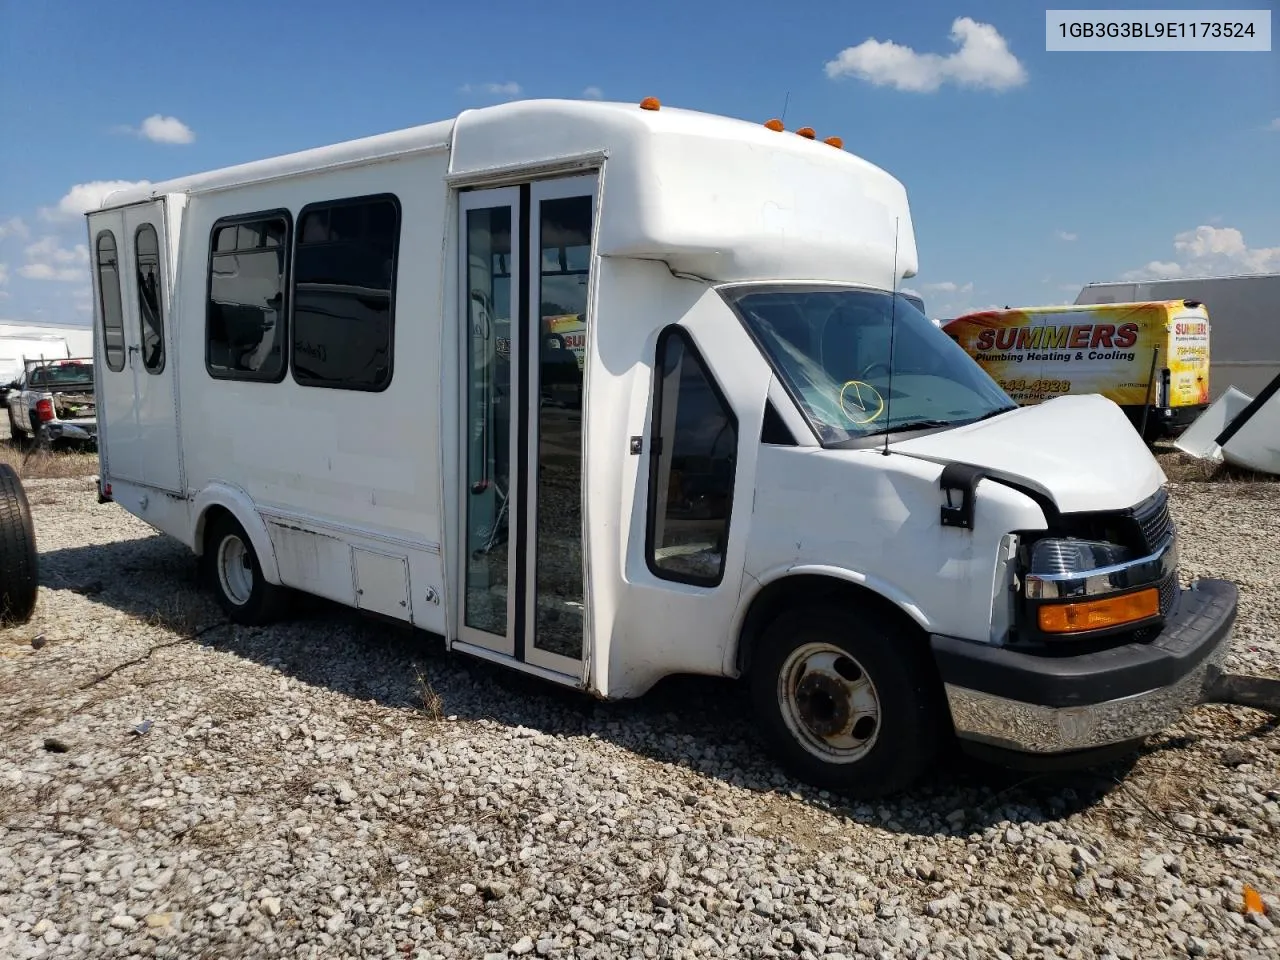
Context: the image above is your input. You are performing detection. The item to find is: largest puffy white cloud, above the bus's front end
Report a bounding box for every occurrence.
[826,17,1027,93]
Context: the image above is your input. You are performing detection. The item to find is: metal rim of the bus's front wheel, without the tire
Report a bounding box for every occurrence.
[778,643,881,763]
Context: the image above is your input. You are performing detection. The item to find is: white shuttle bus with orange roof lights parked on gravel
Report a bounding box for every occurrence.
[88,100,1236,795]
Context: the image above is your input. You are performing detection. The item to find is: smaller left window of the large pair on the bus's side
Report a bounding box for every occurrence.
[205,210,291,383]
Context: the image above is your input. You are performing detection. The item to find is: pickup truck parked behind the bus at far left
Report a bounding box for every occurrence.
[6,357,97,445]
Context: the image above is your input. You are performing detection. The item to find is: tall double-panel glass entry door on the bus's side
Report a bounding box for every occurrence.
[458,174,596,677]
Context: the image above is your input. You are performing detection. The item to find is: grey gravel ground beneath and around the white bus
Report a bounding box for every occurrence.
[0,479,1280,960]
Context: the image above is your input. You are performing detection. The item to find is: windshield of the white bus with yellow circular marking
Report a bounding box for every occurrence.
[722,284,1016,447]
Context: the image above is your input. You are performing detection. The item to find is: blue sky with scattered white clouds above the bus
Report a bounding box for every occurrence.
[0,0,1280,321]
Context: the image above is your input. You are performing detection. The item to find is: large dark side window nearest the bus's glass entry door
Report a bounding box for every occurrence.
[292,195,401,390]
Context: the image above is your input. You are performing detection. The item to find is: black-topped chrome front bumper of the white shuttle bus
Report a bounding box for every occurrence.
[929,580,1238,756]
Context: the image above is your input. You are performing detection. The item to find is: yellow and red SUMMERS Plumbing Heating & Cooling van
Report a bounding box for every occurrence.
[942,300,1210,439]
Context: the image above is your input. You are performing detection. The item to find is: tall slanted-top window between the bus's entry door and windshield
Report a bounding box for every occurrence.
[645,326,737,586]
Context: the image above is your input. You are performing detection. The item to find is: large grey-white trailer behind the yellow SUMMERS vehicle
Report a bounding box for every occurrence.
[1075,273,1280,401]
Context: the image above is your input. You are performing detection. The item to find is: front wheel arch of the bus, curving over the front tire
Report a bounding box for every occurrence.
[726,567,929,676]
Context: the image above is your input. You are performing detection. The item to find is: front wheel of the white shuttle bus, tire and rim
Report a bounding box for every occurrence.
[750,604,945,799]
